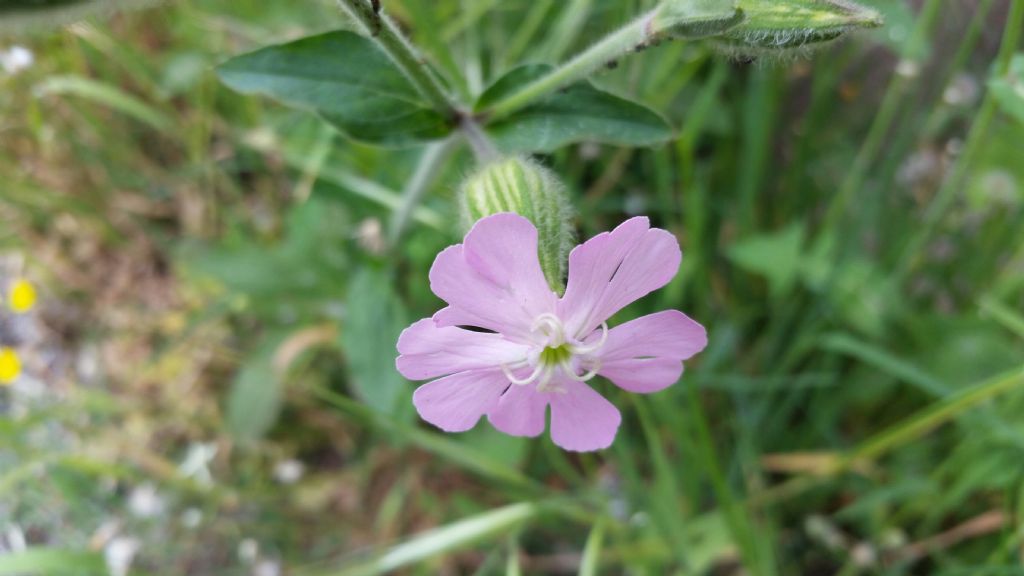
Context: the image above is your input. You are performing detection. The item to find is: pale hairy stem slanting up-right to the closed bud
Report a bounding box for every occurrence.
[486,8,658,119]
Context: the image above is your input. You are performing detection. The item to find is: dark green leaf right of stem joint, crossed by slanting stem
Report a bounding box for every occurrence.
[475,65,672,153]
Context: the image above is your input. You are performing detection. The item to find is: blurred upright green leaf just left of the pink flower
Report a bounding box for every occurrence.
[341,269,410,415]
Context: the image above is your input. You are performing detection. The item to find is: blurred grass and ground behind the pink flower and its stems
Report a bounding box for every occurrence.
[0,0,1024,576]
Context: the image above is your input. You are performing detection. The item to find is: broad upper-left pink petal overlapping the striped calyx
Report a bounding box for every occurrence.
[430,213,557,341]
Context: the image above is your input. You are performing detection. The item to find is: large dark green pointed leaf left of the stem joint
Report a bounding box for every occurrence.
[217,31,452,146]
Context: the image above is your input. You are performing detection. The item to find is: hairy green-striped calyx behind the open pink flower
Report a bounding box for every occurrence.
[462,157,573,294]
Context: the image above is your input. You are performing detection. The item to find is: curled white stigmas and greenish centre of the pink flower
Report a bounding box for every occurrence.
[502,313,608,393]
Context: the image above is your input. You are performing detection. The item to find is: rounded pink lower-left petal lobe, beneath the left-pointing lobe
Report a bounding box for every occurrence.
[413,370,511,431]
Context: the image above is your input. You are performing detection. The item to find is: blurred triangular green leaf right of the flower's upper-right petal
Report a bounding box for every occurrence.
[729,223,804,297]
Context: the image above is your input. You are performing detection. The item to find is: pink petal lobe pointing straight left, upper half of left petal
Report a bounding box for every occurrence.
[395,318,529,380]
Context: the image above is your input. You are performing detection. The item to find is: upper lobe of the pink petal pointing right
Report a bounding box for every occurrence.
[592,310,708,362]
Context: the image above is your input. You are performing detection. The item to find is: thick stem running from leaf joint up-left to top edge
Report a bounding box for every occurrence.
[338,0,461,119]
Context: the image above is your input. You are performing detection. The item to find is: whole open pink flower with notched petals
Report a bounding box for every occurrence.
[396,213,708,452]
